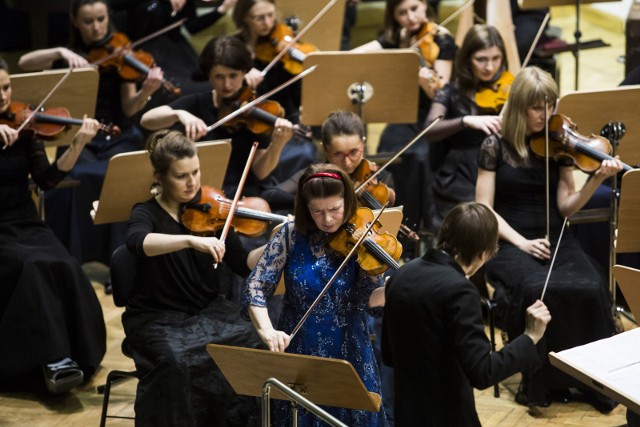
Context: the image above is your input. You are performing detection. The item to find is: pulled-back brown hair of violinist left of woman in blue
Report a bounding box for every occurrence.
[146,129,198,176]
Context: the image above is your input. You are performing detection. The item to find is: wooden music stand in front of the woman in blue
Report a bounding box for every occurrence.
[207,344,381,425]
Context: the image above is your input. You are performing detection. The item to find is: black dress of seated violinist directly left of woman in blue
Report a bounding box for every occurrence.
[122,199,262,427]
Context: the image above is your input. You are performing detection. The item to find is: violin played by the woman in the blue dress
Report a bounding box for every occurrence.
[329,208,402,275]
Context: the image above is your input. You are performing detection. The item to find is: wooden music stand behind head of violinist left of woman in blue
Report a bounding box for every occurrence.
[93,140,231,225]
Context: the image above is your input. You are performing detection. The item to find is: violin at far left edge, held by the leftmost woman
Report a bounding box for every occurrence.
[0,101,120,140]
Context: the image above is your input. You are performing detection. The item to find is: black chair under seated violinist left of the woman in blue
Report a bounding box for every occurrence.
[98,245,138,427]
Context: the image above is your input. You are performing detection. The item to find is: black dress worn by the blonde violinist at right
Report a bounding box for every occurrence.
[478,136,614,401]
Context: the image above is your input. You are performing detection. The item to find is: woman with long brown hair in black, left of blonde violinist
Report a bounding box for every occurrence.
[427,25,507,228]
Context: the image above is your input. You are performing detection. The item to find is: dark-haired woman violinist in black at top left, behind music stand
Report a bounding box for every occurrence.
[20,0,163,264]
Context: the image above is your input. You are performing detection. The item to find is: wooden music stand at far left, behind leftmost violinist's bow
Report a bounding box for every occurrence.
[11,68,99,147]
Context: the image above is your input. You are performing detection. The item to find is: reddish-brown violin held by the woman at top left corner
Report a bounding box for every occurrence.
[88,33,180,96]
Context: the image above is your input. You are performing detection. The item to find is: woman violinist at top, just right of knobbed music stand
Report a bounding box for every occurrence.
[354,0,457,236]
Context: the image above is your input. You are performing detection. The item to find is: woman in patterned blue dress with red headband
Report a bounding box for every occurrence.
[243,164,384,426]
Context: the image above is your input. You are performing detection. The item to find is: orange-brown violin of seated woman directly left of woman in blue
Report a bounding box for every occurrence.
[181,186,287,237]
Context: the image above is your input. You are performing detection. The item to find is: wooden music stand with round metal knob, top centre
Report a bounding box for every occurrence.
[300,49,420,125]
